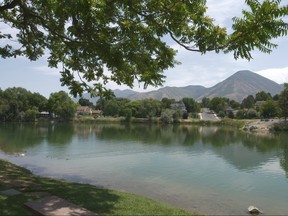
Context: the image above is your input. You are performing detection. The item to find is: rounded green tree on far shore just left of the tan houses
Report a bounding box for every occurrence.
[48,91,76,120]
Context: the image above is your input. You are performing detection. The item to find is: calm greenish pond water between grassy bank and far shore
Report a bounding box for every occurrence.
[0,123,288,215]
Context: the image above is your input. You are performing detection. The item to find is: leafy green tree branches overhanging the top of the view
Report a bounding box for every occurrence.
[0,0,288,96]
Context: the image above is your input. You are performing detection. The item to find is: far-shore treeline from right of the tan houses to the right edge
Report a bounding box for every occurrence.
[96,84,288,123]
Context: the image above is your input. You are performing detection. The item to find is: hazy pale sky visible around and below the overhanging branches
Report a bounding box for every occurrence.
[0,0,288,97]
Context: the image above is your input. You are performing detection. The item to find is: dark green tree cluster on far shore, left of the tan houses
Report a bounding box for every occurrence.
[0,87,76,122]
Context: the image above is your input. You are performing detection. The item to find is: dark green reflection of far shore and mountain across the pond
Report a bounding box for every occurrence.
[0,121,288,177]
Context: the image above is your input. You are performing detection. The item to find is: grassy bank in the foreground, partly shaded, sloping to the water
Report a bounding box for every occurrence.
[0,159,194,215]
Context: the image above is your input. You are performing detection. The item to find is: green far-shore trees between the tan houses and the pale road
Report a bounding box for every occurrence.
[96,97,201,123]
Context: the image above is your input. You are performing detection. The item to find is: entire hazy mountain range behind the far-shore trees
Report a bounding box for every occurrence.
[75,70,283,103]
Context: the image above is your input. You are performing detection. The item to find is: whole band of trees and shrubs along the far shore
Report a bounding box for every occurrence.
[0,84,288,131]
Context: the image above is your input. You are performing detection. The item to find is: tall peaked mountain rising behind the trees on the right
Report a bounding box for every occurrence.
[196,70,283,101]
